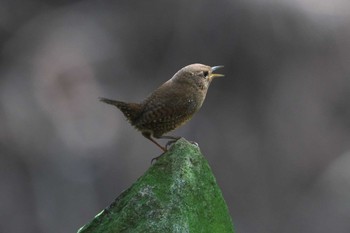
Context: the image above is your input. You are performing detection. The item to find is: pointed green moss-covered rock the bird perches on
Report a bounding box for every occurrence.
[78,139,233,233]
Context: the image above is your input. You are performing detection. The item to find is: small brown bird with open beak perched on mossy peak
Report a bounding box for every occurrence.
[100,64,224,152]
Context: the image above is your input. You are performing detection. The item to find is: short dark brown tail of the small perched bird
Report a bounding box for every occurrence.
[99,98,142,123]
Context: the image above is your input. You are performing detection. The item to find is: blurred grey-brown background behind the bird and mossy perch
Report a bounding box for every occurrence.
[0,0,350,233]
